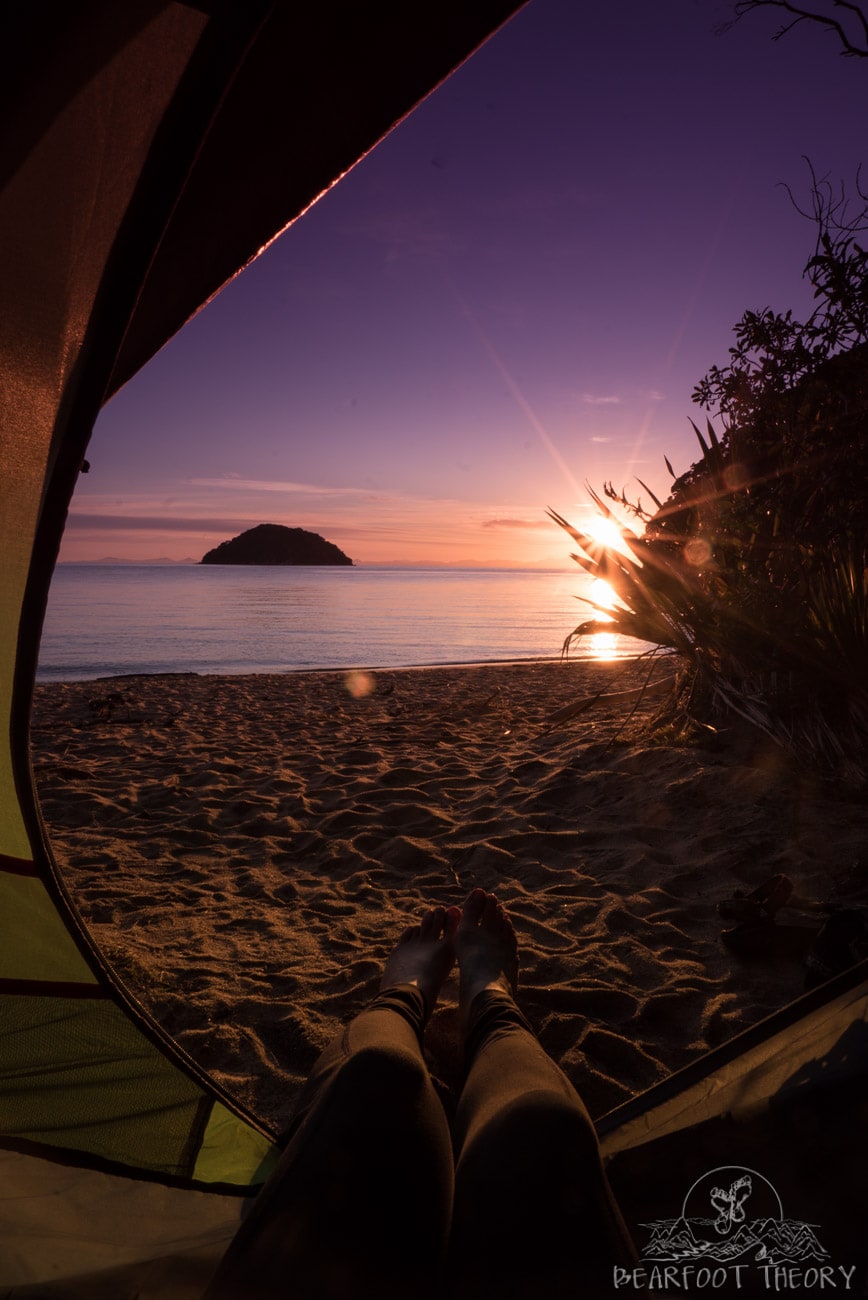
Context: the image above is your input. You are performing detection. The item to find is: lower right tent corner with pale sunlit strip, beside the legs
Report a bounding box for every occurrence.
[598,962,868,1297]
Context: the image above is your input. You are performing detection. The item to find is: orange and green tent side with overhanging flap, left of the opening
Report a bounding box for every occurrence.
[0,0,520,1300]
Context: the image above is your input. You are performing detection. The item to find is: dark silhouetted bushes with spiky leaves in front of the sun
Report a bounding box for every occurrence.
[552,173,868,771]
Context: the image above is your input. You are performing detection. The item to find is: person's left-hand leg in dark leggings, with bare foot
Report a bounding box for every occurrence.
[205,907,459,1300]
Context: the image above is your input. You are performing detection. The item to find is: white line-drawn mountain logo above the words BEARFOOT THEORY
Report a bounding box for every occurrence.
[642,1165,829,1264]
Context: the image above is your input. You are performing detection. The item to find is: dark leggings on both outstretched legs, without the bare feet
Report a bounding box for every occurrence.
[207,984,633,1300]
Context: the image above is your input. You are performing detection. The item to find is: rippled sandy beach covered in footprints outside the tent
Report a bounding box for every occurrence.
[32,662,868,1128]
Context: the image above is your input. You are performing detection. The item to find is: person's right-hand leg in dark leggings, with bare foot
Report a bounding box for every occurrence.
[450,891,634,1300]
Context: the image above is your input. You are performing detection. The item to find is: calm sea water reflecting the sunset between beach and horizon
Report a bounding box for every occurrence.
[38,564,645,681]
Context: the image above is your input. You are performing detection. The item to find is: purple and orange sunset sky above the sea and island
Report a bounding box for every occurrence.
[61,0,868,567]
